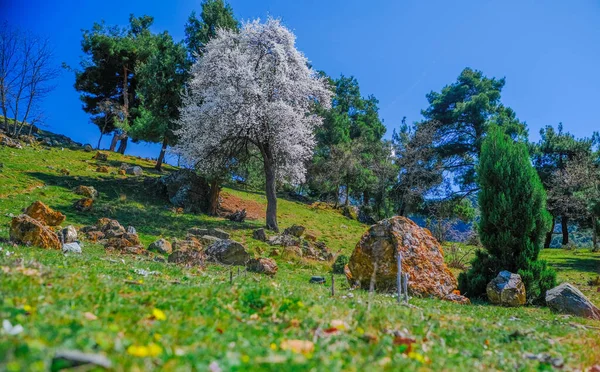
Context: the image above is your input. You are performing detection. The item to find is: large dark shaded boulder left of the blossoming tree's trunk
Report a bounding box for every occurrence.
[154,169,210,212]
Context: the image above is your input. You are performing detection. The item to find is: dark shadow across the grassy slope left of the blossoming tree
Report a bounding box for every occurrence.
[28,172,258,237]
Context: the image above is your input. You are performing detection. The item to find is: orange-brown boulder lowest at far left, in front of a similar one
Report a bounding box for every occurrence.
[10,214,61,249]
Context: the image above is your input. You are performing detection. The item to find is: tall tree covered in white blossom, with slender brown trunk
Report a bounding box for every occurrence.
[178,19,332,231]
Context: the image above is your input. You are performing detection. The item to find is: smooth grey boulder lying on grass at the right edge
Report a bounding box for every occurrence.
[546,283,600,320]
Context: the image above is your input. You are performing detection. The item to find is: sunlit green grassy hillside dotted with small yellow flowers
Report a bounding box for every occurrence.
[0,142,600,371]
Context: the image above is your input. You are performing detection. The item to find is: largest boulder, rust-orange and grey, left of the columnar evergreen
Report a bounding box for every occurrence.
[347,216,457,298]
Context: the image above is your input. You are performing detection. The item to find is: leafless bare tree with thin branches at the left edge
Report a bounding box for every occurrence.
[0,22,60,136]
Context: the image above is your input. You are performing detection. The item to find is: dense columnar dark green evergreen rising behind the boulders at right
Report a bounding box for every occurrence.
[459,126,556,302]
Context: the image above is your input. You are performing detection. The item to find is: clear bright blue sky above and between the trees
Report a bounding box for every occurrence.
[0,0,600,161]
